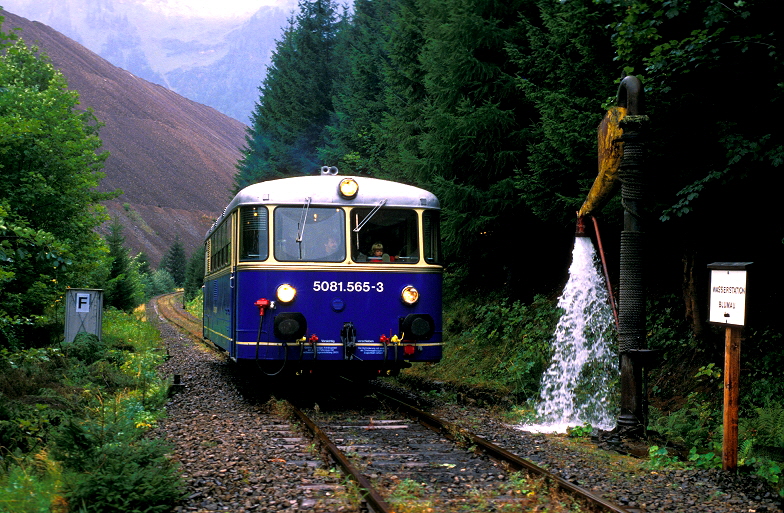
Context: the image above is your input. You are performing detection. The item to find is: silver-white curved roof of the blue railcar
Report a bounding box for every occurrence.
[208,175,441,234]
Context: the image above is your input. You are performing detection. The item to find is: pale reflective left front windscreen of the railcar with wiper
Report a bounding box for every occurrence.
[274,205,346,262]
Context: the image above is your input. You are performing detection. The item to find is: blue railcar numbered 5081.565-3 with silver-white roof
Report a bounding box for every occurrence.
[204,168,442,375]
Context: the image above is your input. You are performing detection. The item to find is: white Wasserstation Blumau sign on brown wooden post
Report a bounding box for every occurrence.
[708,262,751,470]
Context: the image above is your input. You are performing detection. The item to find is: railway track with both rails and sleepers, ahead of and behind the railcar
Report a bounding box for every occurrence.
[156,293,634,513]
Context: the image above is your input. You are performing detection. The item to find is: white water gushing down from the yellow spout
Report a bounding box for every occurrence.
[521,237,618,432]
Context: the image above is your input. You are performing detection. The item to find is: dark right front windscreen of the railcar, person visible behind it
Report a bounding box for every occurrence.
[351,208,419,264]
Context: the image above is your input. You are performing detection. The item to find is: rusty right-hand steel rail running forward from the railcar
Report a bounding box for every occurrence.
[376,391,631,513]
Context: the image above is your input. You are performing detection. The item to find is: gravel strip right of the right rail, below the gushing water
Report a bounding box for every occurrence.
[426,390,784,513]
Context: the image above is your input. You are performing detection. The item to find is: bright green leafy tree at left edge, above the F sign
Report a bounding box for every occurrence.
[0,30,113,346]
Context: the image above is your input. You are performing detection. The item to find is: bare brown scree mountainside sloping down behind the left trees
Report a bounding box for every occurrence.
[0,11,246,266]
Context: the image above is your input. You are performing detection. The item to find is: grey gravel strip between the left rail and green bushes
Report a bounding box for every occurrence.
[148,309,356,513]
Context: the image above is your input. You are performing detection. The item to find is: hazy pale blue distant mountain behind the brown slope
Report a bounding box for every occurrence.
[0,0,294,123]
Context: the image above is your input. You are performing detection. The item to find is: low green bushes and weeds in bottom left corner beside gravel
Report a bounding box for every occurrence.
[0,309,182,512]
